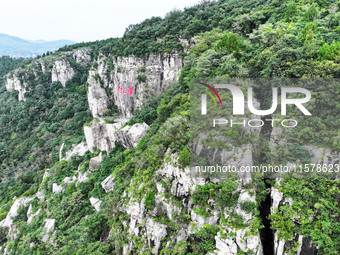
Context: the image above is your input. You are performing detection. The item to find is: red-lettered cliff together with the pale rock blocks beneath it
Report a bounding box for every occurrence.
[84,51,183,154]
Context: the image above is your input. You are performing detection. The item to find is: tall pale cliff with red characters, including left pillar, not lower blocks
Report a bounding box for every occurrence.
[87,54,183,117]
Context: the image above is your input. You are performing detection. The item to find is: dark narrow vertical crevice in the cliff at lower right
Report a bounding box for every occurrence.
[256,116,274,255]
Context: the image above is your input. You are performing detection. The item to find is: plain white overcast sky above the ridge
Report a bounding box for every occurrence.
[0,0,200,42]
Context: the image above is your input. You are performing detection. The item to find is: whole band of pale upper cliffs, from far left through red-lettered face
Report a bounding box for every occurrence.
[6,49,183,117]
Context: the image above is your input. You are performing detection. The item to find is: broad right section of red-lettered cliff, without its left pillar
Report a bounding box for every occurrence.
[113,54,183,116]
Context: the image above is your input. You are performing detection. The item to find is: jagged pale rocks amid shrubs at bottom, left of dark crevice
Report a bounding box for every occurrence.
[122,150,263,255]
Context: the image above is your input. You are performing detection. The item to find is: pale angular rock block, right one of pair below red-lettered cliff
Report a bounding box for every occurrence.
[114,123,150,149]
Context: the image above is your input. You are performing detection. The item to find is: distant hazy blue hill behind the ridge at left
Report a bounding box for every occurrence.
[0,34,75,58]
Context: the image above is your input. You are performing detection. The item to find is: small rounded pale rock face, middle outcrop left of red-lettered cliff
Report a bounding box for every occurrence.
[51,59,75,87]
